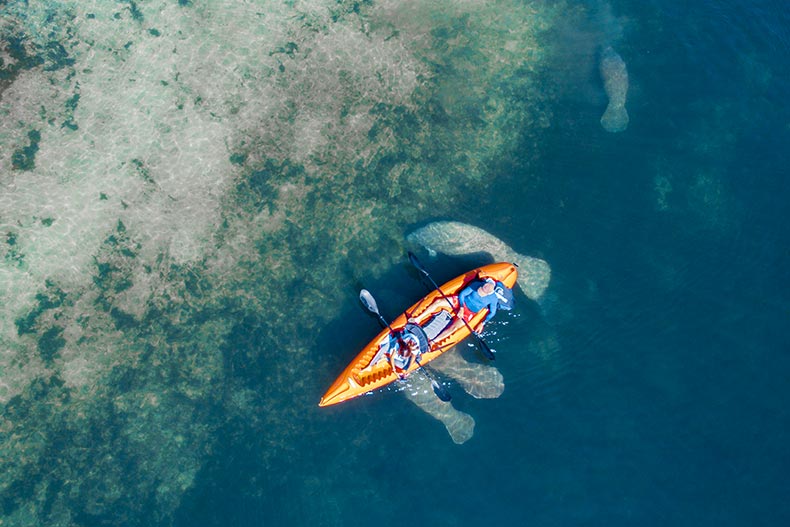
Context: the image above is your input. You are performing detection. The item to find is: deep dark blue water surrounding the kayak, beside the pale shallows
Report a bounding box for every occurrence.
[0,0,790,527]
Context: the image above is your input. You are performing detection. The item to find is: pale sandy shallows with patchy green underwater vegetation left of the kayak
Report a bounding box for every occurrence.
[0,0,561,526]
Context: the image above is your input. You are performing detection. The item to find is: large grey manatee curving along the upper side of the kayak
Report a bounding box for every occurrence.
[406,221,551,301]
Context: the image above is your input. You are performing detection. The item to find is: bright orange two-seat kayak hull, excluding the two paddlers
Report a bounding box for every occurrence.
[318,262,518,406]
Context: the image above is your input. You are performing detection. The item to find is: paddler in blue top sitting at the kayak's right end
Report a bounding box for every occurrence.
[409,278,499,342]
